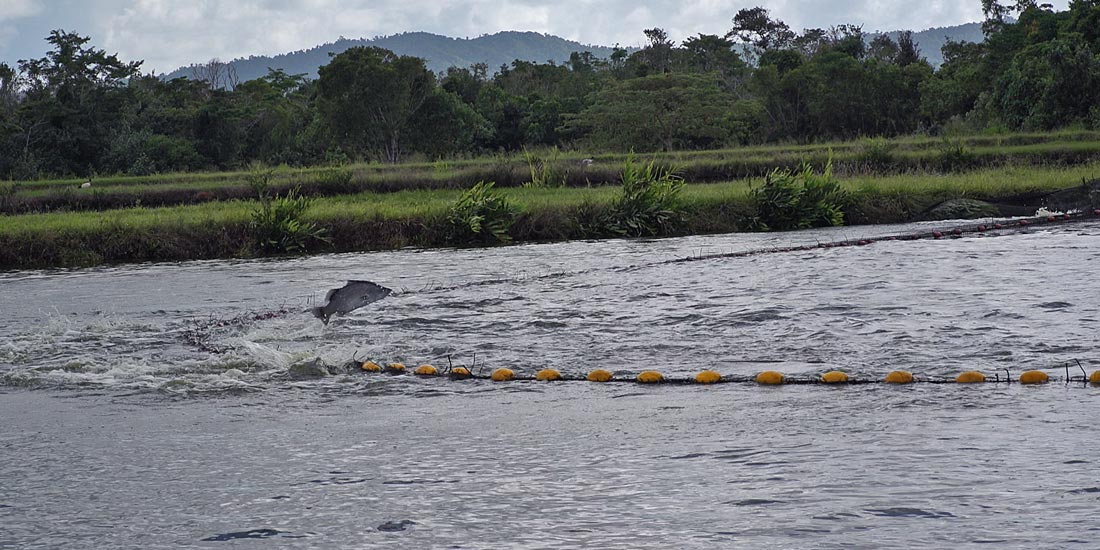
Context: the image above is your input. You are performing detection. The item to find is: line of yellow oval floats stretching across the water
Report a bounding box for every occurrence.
[349,360,1100,386]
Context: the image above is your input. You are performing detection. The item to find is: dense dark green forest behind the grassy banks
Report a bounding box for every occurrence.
[0,0,1100,179]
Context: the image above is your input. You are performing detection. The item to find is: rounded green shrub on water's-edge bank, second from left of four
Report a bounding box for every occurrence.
[447,182,517,243]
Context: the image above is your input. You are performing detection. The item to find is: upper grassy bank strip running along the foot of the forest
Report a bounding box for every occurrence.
[0,132,1100,215]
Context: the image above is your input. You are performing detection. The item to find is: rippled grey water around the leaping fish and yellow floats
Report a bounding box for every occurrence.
[0,221,1100,549]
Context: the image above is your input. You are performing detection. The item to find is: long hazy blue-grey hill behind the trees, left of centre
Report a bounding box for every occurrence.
[166,31,629,83]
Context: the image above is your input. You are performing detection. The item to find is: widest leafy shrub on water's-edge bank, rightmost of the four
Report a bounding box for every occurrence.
[751,161,848,231]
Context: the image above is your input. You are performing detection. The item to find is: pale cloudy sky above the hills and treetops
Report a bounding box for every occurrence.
[0,0,1067,73]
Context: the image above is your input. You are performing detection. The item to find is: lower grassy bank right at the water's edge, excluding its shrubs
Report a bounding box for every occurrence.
[0,163,1100,270]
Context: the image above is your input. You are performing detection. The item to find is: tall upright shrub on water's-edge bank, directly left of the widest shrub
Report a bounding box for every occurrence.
[606,153,684,237]
